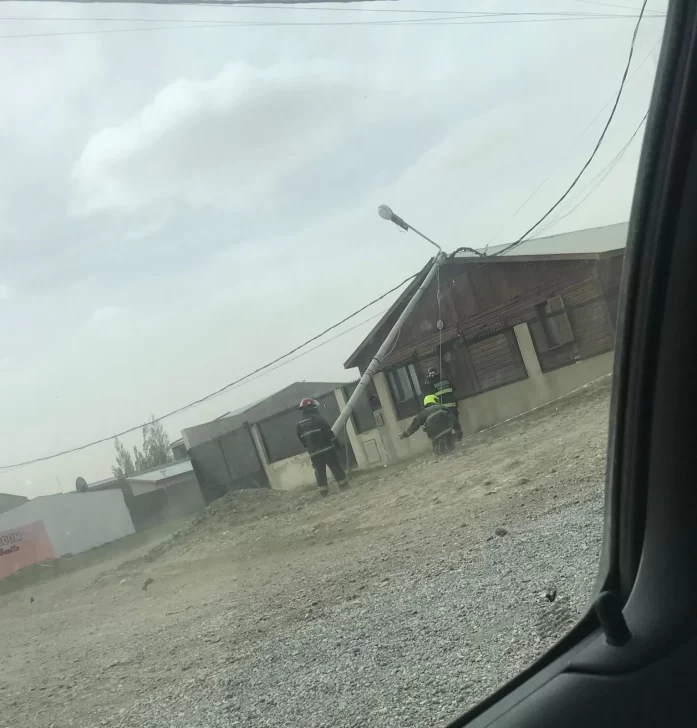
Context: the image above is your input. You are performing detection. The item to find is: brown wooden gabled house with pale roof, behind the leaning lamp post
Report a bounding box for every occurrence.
[345,223,627,419]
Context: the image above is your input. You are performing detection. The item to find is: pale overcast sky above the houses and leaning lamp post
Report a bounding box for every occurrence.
[0,0,665,497]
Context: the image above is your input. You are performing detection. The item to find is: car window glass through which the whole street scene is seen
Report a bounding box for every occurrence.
[0,0,667,728]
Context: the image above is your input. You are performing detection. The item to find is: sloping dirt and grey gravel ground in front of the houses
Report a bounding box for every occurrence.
[0,385,608,728]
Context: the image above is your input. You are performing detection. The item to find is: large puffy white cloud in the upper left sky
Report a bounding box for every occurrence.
[74,63,378,223]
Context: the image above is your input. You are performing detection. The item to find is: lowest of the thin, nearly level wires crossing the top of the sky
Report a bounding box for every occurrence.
[0,14,665,40]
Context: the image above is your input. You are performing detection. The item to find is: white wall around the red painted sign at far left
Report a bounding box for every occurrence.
[0,490,135,556]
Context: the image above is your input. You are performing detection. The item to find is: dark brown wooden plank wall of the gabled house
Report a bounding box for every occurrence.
[359,250,622,386]
